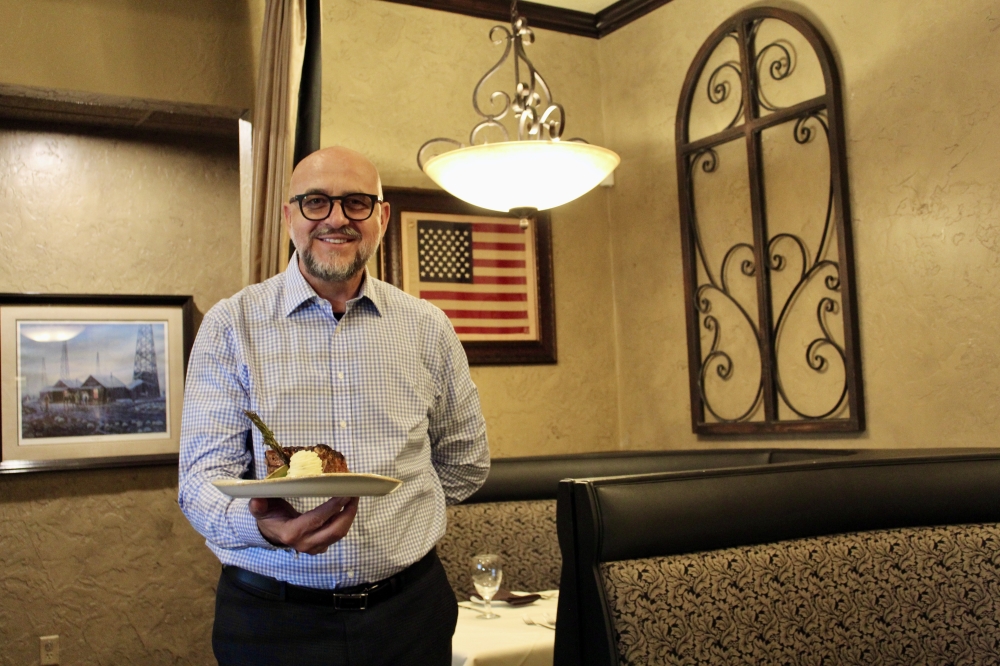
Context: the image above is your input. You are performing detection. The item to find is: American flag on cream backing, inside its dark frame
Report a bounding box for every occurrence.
[403,213,538,340]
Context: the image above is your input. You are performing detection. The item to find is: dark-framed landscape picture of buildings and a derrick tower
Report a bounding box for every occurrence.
[0,294,193,473]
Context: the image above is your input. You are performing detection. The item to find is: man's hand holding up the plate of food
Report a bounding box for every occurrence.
[250,497,358,555]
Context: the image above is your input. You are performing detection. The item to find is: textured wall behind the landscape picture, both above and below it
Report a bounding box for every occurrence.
[0,127,240,665]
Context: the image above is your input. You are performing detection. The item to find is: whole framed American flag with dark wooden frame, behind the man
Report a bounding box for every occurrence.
[379,188,556,365]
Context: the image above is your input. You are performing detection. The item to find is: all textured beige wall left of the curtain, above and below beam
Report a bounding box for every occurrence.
[0,0,250,666]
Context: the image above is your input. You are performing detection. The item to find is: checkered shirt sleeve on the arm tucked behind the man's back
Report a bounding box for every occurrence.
[428,313,490,504]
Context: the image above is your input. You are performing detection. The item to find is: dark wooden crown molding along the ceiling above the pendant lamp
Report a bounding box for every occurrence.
[383,0,670,39]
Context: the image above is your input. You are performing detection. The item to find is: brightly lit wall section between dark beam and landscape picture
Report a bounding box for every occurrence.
[0,129,240,312]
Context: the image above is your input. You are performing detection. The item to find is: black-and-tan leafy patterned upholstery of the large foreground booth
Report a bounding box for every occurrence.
[601,524,1000,664]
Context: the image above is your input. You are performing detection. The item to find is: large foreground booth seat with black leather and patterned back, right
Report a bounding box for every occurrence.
[555,449,1000,666]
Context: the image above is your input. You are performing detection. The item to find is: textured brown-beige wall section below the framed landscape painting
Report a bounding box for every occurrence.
[0,467,219,666]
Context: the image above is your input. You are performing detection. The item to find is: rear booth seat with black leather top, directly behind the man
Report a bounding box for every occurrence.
[437,449,855,599]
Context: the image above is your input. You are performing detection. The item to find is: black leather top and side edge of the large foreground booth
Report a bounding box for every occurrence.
[555,450,1000,666]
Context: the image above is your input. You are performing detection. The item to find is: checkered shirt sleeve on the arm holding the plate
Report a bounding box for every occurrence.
[178,305,275,549]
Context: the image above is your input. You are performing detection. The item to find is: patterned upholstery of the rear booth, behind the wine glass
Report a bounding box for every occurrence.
[437,500,562,599]
